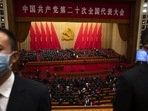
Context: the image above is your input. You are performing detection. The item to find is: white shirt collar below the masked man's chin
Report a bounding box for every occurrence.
[0,72,14,98]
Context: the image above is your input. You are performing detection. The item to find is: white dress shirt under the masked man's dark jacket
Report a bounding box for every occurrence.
[0,72,14,111]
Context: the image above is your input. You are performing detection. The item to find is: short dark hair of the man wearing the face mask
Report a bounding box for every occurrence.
[0,27,17,51]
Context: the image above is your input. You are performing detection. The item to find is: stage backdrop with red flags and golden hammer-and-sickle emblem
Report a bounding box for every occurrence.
[20,21,127,55]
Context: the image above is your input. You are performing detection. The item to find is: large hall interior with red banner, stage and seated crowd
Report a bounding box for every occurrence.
[0,0,148,111]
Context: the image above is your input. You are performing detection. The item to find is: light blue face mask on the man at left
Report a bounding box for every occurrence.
[0,53,12,77]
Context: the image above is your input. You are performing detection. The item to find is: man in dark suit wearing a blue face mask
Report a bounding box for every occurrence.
[0,28,51,111]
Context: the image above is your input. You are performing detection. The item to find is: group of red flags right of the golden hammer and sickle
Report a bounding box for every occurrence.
[74,23,102,49]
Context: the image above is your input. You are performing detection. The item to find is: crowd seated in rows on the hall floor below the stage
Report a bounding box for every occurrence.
[17,69,119,106]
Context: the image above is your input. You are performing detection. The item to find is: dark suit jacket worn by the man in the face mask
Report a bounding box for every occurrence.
[6,76,51,111]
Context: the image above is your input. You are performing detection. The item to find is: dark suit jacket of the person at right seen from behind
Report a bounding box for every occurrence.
[113,64,148,111]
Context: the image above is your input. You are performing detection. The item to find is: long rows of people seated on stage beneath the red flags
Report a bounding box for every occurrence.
[19,49,120,62]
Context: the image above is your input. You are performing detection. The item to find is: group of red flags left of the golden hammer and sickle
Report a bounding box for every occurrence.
[30,22,61,50]
